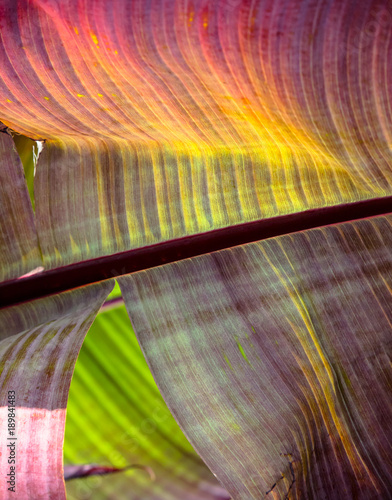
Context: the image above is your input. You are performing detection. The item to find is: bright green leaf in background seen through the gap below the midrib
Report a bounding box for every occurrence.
[64,305,229,500]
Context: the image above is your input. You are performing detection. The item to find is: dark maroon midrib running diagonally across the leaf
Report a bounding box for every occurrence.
[0,196,392,307]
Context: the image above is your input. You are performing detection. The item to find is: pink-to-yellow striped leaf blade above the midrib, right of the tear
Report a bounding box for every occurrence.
[0,0,392,268]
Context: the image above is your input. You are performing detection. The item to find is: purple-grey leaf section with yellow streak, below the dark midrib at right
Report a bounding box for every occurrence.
[119,216,392,500]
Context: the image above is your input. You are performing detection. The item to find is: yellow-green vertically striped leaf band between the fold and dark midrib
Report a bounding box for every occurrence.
[35,132,389,268]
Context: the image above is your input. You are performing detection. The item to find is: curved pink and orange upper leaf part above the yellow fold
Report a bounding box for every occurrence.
[0,0,391,177]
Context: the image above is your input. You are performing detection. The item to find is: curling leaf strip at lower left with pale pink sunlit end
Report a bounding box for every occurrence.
[0,282,112,500]
